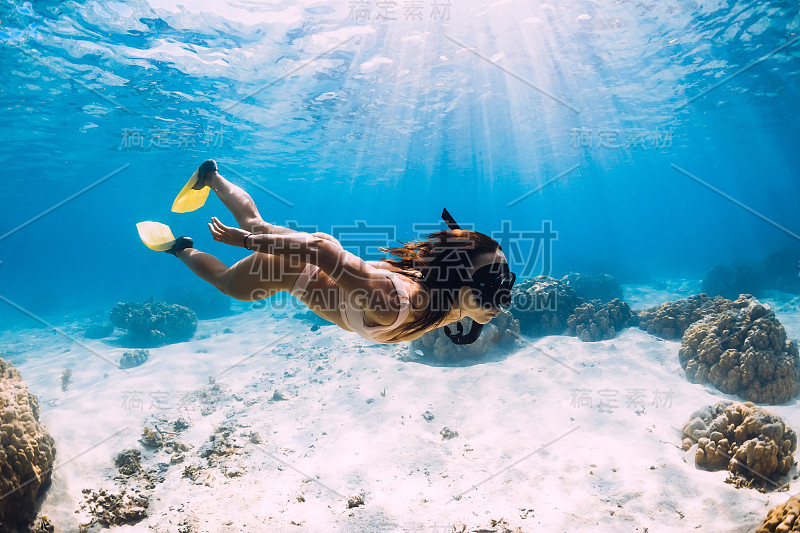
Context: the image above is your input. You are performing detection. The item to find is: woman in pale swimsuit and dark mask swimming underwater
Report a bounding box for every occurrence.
[142,160,516,344]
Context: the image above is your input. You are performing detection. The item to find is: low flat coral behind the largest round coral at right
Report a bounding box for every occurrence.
[639,294,731,340]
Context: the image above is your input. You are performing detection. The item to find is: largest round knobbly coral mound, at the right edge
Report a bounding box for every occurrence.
[678,295,800,404]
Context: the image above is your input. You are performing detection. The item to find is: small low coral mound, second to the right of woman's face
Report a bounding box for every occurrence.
[567,298,635,342]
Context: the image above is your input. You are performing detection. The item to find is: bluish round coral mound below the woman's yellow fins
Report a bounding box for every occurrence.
[111,302,197,347]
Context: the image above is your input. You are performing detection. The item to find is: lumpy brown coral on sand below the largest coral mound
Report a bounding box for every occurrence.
[683,401,797,488]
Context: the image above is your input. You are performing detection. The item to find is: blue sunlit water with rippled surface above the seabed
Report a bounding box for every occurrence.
[0,0,800,325]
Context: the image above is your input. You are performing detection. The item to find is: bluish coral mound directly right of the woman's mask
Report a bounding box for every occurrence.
[511,276,581,337]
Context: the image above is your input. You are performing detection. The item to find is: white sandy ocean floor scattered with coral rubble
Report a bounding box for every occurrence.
[0,282,800,533]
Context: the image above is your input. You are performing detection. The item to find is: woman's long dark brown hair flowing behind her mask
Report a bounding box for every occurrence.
[379,229,502,335]
